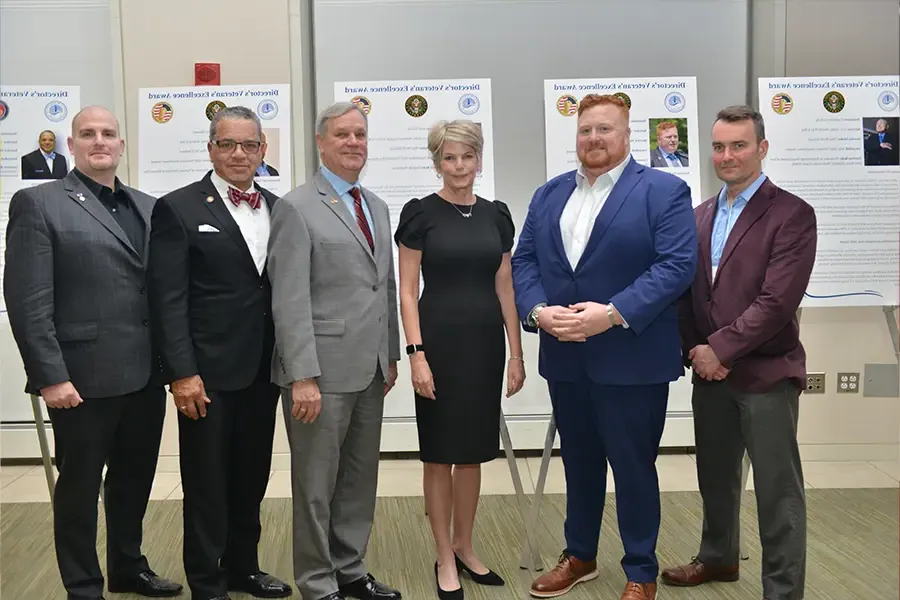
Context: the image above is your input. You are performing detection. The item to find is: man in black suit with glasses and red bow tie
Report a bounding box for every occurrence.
[149,106,291,600]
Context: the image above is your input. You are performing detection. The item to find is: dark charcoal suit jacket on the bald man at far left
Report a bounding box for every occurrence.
[3,172,157,398]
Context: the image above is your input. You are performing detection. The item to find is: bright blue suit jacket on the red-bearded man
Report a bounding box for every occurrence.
[512,158,698,385]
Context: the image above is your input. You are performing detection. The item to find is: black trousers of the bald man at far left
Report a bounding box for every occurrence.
[48,387,166,600]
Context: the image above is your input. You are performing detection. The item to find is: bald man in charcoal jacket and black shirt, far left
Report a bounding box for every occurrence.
[4,107,182,600]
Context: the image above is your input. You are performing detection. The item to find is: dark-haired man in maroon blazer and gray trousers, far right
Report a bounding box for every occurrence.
[662,106,816,600]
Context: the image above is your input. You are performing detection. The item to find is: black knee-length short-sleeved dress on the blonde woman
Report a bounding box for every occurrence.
[394,194,515,464]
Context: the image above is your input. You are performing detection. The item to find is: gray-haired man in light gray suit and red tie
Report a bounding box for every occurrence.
[268,102,400,600]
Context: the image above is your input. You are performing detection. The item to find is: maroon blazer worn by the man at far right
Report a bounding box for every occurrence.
[679,179,816,393]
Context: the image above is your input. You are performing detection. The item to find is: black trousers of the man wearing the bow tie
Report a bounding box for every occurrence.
[178,383,279,600]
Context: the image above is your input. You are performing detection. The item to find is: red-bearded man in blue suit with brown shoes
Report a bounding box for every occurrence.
[512,94,697,600]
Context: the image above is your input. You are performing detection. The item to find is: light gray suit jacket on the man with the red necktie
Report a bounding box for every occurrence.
[268,172,400,394]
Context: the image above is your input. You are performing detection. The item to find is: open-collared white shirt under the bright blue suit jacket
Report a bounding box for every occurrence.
[559,155,631,269]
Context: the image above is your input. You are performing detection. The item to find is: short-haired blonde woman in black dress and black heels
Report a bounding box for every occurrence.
[394,121,525,600]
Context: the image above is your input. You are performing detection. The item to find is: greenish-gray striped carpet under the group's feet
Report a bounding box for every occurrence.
[0,489,900,600]
